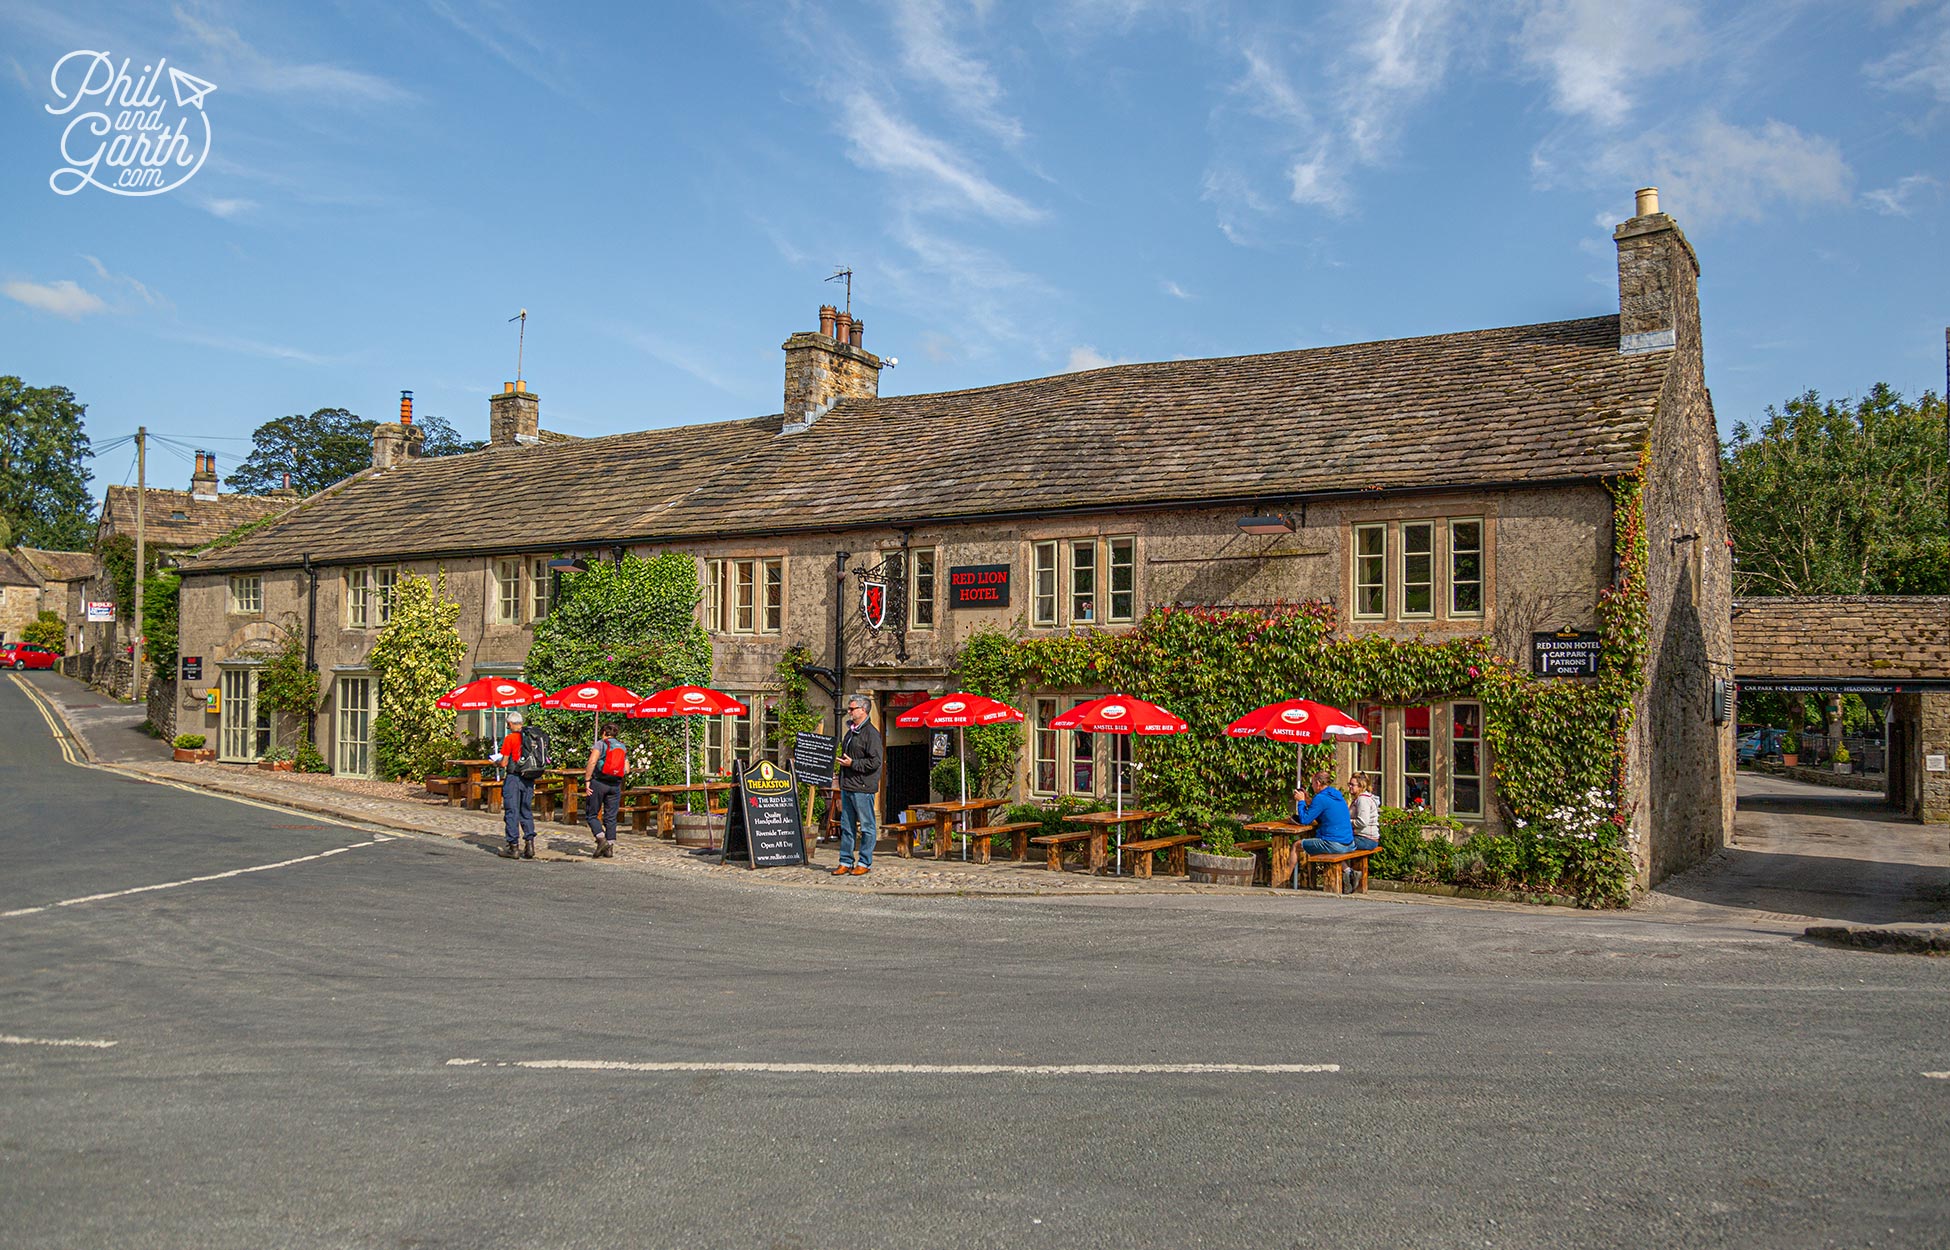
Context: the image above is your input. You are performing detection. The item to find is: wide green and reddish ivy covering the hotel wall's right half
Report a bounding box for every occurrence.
[957,469,1646,905]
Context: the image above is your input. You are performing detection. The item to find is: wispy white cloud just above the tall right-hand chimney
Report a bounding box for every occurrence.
[1597,113,1854,224]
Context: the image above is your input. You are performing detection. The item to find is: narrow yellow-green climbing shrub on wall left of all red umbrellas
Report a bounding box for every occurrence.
[367,573,468,780]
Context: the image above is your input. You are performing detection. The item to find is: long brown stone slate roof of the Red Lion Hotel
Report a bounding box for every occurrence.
[191,316,1669,569]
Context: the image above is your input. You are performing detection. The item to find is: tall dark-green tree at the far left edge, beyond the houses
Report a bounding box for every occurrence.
[0,376,94,552]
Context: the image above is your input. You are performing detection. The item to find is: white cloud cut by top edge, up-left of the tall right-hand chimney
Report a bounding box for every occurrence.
[1517,0,1706,127]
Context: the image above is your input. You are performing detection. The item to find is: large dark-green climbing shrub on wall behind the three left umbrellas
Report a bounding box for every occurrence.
[523,552,712,784]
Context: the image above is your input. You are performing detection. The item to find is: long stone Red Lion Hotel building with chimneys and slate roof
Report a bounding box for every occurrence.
[181,193,1734,879]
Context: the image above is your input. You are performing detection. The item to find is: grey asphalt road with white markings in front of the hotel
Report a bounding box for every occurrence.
[0,681,1950,1250]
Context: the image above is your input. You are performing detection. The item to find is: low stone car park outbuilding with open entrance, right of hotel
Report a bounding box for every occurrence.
[1734,595,1950,825]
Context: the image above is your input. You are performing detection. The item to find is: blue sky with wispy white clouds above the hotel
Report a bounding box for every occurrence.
[0,0,1950,491]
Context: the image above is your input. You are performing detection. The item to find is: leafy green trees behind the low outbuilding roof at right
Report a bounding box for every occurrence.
[1720,382,1950,595]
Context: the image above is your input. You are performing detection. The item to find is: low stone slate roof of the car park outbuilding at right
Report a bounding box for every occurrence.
[1734,595,1950,681]
